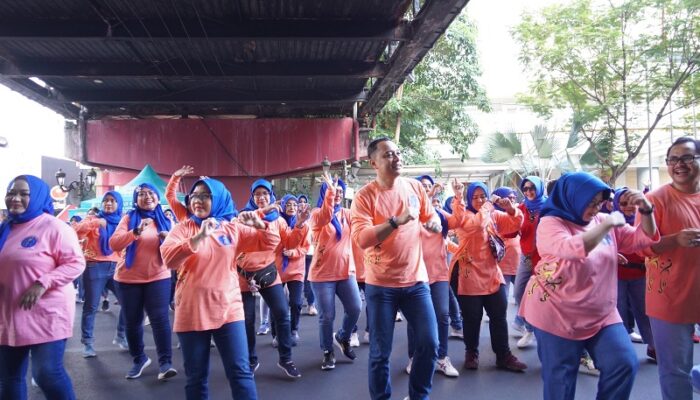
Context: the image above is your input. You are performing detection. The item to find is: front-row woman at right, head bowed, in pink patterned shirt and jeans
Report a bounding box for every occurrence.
[520,172,658,400]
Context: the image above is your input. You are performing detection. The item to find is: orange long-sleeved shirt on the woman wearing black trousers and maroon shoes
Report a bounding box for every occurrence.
[450,205,523,296]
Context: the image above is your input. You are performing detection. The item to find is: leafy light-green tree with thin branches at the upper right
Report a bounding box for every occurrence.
[513,0,700,182]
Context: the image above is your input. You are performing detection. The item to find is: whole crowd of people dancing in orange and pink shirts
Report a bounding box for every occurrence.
[0,137,700,400]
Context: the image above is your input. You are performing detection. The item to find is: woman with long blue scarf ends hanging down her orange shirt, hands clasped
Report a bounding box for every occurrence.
[109,183,177,381]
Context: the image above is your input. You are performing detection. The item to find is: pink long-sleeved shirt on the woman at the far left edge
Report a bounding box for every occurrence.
[0,214,85,347]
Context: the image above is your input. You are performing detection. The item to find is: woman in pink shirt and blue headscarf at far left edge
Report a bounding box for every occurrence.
[0,175,85,400]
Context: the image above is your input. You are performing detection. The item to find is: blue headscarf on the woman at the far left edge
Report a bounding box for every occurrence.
[0,175,53,252]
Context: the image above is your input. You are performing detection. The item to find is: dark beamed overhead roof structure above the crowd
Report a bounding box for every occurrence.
[0,0,468,119]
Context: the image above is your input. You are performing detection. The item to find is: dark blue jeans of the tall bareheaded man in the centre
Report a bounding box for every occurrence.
[365,282,438,400]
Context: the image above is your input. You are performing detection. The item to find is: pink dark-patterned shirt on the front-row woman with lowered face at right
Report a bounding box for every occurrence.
[520,214,659,340]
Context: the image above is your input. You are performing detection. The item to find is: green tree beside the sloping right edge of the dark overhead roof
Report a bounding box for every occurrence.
[372,11,490,164]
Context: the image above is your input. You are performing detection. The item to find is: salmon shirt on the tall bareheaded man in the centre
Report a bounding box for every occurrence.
[348,177,436,288]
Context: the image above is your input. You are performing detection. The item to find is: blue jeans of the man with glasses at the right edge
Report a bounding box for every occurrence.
[649,317,695,400]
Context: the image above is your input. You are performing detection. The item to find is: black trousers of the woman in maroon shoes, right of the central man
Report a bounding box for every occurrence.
[457,285,510,358]
